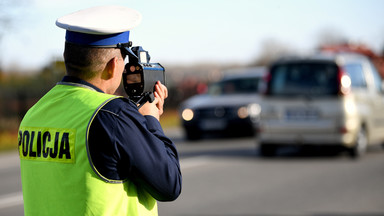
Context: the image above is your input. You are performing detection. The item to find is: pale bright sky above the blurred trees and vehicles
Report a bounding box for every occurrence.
[0,0,384,70]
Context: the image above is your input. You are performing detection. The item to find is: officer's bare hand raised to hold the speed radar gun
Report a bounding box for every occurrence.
[139,82,168,120]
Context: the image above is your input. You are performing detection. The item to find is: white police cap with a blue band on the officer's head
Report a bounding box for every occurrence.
[56,6,141,47]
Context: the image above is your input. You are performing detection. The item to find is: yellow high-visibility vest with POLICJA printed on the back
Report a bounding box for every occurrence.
[19,83,157,216]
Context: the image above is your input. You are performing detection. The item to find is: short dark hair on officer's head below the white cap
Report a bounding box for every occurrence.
[64,42,121,80]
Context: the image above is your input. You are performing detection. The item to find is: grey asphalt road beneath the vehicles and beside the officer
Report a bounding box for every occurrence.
[0,127,384,216]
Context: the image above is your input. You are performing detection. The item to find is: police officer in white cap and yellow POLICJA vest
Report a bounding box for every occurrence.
[19,6,181,216]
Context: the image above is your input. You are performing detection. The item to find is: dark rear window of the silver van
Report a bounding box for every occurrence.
[268,63,338,96]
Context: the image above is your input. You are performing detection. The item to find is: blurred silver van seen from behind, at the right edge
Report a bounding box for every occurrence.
[258,53,384,158]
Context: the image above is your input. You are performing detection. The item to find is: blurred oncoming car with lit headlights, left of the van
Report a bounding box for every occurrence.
[180,70,264,140]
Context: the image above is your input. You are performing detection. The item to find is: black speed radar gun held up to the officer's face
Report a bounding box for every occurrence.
[122,43,165,108]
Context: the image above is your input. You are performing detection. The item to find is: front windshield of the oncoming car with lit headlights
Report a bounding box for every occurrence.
[208,77,260,95]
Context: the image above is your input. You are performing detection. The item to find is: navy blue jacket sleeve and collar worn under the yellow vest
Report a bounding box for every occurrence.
[62,76,182,201]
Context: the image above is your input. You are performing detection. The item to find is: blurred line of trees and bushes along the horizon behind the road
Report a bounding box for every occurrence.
[0,40,384,137]
